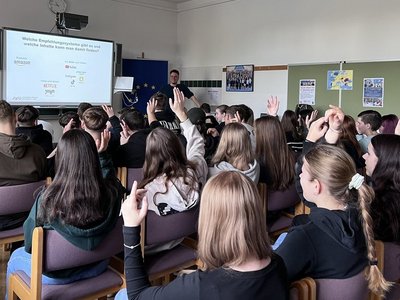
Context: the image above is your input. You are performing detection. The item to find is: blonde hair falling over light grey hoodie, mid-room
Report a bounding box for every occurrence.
[211,123,254,171]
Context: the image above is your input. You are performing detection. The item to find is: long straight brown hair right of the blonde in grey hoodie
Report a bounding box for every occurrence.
[254,116,295,190]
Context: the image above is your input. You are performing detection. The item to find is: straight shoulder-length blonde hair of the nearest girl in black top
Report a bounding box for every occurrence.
[198,171,272,270]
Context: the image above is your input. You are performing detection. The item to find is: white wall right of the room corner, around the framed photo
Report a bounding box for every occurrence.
[177,0,400,117]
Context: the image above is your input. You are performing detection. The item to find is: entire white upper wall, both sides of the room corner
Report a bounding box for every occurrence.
[0,0,400,122]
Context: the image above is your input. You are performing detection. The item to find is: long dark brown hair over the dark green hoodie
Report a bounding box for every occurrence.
[38,129,116,227]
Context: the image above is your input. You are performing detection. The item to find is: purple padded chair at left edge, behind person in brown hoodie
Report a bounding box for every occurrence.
[0,180,46,244]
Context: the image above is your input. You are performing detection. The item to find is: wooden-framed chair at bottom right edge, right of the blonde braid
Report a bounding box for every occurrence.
[370,241,400,300]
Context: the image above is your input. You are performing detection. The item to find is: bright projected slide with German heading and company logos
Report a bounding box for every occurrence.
[3,29,113,106]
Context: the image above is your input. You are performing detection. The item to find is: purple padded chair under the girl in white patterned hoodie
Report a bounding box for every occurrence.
[141,206,200,283]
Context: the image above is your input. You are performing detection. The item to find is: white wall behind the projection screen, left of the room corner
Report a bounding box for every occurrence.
[0,0,177,140]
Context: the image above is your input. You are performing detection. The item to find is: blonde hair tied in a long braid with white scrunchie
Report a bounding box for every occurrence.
[304,145,392,296]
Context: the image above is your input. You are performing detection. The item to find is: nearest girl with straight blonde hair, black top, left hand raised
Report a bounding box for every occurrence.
[115,171,289,300]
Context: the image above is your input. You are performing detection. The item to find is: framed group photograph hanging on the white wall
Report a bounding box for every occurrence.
[226,65,254,92]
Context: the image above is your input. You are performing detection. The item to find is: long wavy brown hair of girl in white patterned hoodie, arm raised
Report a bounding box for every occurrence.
[139,127,198,189]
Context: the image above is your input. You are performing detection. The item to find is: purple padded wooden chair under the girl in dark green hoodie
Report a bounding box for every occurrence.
[8,219,125,300]
